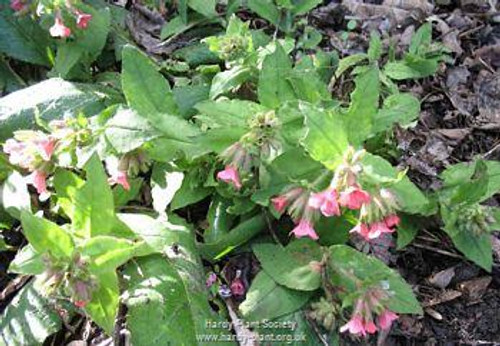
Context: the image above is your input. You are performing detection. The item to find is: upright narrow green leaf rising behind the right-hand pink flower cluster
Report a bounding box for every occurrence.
[342,67,380,147]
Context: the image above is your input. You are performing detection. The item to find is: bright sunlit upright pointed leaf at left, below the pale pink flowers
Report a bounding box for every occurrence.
[72,154,115,238]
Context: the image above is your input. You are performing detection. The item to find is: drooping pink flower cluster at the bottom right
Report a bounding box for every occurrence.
[340,287,398,336]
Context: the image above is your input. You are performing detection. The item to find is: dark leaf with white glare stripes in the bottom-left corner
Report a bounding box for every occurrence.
[0,281,61,346]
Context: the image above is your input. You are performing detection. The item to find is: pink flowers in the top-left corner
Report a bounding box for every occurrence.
[10,0,92,38]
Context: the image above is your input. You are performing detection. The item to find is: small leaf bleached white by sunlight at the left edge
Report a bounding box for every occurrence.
[0,171,31,219]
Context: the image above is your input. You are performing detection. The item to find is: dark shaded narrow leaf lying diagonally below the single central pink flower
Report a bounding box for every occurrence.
[198,214,268,261]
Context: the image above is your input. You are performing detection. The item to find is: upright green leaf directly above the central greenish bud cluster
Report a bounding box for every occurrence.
[257,42,296,108]
